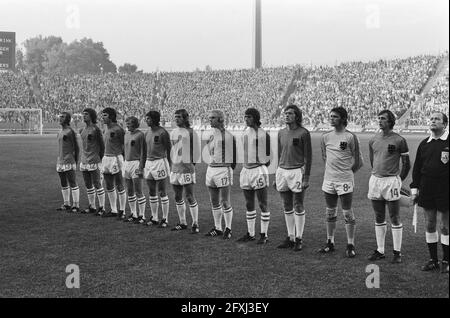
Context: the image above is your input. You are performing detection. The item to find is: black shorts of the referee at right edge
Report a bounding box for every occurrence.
[417,175,449,213]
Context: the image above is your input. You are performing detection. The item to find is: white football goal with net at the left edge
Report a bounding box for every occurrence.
[0,108,43,135]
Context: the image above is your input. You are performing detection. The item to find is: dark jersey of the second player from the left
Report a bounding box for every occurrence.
[80,125,104,164]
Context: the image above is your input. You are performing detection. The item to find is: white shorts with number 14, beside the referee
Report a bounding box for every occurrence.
[367,175,402,201]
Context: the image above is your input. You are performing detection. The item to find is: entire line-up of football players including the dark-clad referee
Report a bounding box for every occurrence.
[57,105,448,272]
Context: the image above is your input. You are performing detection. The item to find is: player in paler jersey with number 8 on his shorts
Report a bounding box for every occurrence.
[319,107,362,258]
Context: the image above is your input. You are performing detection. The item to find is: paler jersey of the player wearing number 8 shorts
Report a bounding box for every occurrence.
[320,130,359,182]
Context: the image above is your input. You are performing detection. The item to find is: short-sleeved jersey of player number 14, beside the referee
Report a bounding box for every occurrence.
[369,132,409,178]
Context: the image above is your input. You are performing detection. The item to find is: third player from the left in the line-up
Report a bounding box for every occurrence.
[102,107,127,219]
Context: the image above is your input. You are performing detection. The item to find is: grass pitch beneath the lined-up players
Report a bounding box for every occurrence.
[0,134,449,298]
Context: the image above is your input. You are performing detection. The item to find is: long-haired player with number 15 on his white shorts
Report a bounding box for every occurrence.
[238,108,270,244]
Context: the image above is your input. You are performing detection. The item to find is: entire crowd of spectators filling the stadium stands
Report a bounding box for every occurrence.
[0,55,448,127]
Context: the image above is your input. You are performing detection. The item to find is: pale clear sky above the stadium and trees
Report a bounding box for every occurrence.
[0,0,449,72]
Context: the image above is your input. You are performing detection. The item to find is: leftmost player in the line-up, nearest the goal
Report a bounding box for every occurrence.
[56,112,80,212]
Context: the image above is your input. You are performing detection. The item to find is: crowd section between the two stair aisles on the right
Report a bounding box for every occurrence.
[290,55,442,127]
